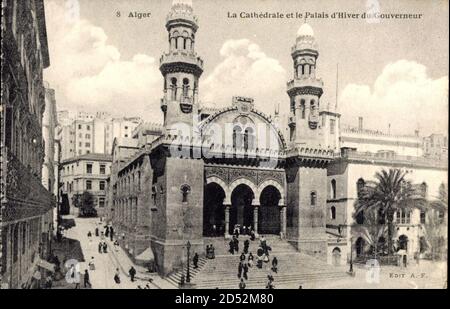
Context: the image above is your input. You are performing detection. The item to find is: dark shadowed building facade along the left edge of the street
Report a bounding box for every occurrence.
[0,0,55,288]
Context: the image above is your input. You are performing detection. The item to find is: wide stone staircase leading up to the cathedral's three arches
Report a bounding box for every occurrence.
[167,236,348,289]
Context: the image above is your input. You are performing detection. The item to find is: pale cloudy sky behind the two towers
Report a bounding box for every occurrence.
[44,0,449,135]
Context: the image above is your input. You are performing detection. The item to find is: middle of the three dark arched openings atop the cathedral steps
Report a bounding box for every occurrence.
[230,184,255,232]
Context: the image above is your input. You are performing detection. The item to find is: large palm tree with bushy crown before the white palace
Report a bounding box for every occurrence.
[355,169,427,254]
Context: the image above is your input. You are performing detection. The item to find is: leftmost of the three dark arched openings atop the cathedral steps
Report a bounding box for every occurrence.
[203,182,225,237]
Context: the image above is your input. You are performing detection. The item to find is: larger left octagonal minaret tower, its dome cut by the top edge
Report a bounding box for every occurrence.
[159,0,203,134]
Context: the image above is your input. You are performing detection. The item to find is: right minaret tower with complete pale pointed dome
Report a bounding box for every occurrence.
[287,23,323,147]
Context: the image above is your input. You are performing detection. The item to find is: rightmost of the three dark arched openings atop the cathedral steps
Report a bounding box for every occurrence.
[258,185,281,235]
